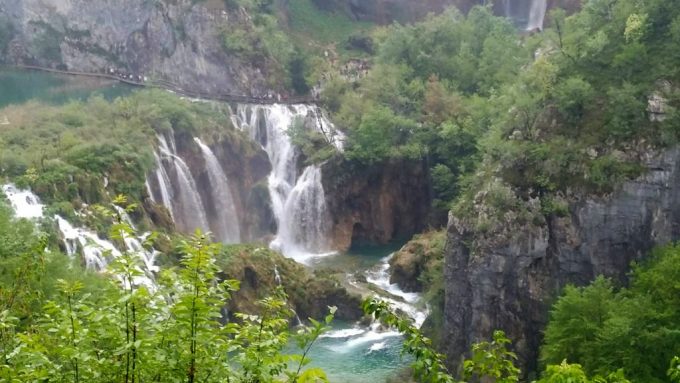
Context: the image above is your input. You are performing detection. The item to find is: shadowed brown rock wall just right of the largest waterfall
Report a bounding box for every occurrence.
[322,160,431,251]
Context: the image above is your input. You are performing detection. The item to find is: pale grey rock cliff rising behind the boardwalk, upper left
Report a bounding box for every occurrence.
[0,0,265,95]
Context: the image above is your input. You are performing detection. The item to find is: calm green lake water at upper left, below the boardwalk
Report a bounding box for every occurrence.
[0,69,135,108]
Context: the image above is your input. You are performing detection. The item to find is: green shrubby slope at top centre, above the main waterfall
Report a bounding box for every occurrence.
[219,0,373,95]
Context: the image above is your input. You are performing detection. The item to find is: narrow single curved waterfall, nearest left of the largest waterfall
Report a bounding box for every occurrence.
[194,138,241,243]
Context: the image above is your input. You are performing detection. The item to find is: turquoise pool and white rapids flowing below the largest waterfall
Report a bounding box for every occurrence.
[284,244,427,383]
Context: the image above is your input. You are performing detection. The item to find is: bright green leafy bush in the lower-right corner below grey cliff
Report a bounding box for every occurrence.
[542,244,680,382]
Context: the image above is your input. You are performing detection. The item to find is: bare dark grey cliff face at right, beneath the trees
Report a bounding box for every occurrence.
[443,149,680,371]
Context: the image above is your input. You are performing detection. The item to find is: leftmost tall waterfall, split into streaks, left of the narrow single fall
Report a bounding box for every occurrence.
[157,135,210,233]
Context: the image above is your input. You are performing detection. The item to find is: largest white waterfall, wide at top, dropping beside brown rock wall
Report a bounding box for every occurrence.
[232,104,342,263]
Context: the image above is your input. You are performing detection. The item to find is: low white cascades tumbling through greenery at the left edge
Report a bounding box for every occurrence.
[2,184,158,288]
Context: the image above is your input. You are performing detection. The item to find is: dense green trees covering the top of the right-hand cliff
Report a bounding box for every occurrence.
[323,0,680,225]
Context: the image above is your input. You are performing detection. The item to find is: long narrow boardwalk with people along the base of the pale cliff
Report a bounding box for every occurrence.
[10,65,318,104]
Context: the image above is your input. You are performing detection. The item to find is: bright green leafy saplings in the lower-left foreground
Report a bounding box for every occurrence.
[0,197,335,383]
